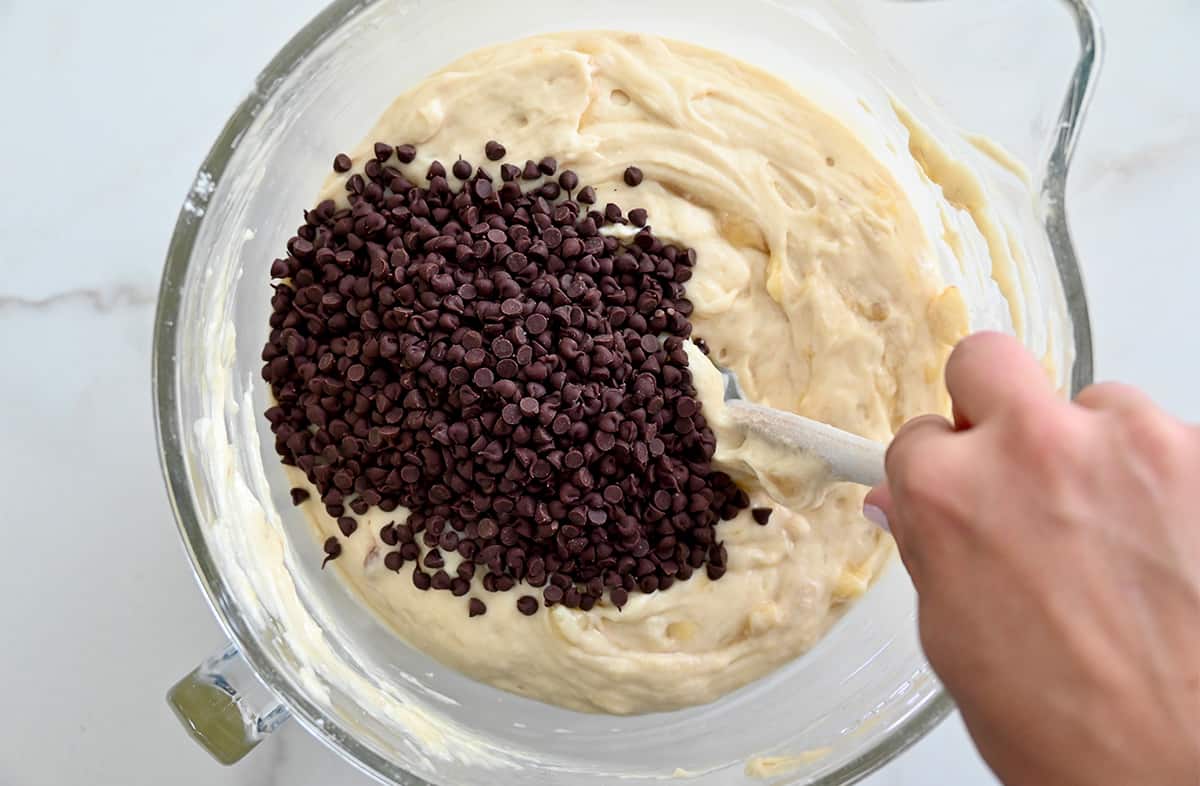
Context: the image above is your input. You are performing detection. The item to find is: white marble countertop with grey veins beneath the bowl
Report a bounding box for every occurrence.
[0,0,1200,786]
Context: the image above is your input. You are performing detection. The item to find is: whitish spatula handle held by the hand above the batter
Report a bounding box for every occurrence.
[725,401,887,486]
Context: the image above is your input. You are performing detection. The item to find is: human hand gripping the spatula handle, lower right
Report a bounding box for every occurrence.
[866,334,1200,786]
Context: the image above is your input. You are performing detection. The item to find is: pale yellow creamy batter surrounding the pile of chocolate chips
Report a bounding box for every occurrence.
[294,32,967,713]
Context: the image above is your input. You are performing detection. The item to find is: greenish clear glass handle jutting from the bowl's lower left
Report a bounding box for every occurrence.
[167,644,292,764]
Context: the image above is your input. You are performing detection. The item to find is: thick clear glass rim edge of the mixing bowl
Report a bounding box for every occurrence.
[151,0,1104,786]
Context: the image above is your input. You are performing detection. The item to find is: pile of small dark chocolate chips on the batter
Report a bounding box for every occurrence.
[263,142,749,616]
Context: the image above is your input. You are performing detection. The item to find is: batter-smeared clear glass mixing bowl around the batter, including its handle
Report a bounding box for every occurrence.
[154,0,1099,786]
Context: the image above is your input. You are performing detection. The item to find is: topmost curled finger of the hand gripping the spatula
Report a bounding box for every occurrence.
[946,332,1054,427]
